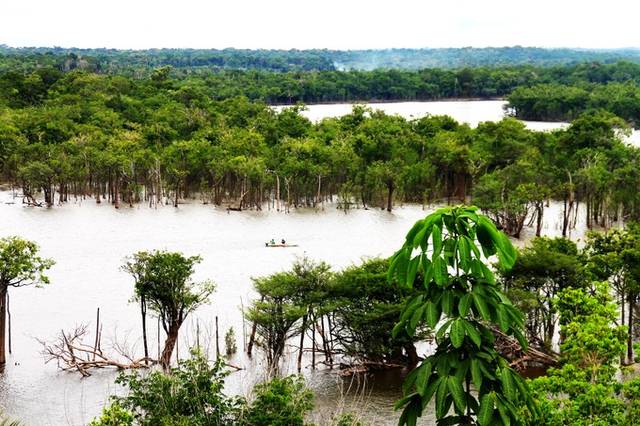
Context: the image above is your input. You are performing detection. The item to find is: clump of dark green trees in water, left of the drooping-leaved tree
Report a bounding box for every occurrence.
[246,258,429,373]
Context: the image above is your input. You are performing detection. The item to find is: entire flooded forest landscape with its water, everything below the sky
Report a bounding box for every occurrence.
[0,45,640,426]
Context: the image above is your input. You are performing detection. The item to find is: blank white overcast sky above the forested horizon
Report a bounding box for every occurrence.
[0,0,640,49]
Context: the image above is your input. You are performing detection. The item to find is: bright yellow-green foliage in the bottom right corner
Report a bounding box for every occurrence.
[527,283,640,426]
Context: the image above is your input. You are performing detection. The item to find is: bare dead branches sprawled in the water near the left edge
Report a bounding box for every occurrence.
[38,324,155,377]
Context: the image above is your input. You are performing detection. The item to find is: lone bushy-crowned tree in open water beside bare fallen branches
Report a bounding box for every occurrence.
[125,251,215,370]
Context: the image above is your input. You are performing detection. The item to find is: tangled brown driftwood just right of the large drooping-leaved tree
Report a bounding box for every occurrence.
[492,327,559,372]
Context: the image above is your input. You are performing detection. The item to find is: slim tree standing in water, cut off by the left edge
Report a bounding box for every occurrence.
[0,237,54,368]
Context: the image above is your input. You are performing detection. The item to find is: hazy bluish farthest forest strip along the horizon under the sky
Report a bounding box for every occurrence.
[0,45,640,75]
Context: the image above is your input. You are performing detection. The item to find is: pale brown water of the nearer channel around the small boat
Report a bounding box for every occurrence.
[0,191,592,425]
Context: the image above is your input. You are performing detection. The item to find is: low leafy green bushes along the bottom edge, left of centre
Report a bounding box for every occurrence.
[91,352,313,426]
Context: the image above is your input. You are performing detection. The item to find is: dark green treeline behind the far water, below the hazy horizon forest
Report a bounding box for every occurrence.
[0,58,640,111]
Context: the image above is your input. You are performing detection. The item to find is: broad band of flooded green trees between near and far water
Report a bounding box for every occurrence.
[0,68,640,240]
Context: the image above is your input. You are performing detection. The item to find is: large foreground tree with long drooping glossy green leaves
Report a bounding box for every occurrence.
[389,207,537,426]
